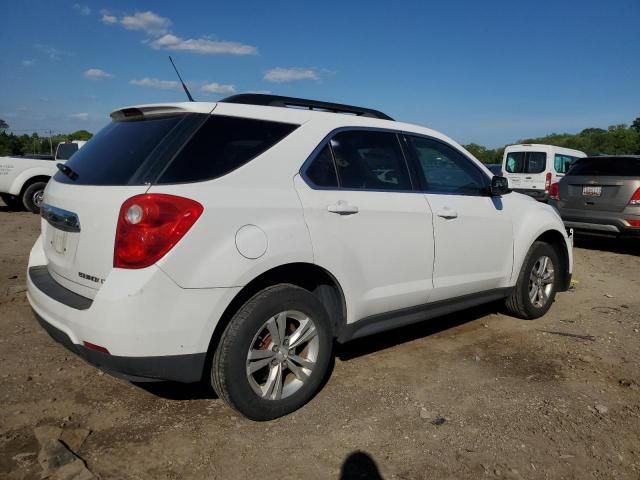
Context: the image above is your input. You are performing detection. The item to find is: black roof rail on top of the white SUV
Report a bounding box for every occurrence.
[219,93,393,120]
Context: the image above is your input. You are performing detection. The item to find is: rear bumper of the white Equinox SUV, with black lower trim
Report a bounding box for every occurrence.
[27,235,240,382]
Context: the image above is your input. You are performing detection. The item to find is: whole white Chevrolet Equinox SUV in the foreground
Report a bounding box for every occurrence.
[28,95,572,420]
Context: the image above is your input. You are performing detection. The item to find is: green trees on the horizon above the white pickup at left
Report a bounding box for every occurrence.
[0,119,93,156]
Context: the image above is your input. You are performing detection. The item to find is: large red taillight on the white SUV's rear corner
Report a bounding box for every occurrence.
[113,193,204,268]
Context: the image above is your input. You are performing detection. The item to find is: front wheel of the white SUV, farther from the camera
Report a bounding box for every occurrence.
[505,242,560,320]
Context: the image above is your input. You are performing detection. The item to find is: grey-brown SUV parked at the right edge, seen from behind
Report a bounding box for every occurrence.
[549,155,640,238]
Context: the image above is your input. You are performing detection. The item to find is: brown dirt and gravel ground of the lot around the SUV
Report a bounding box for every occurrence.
[0,206,640,480]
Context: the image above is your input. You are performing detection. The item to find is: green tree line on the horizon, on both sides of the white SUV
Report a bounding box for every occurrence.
[0,117,640,163]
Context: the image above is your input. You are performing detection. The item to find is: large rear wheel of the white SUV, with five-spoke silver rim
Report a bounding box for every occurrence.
[211,284,333,421]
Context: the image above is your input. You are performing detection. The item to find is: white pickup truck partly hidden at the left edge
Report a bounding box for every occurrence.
[0,140,87,213]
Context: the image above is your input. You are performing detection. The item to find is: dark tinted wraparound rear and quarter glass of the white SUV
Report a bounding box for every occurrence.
[54,113,298,186]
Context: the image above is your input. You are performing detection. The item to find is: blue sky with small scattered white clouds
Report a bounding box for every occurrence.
[0,0,640,147]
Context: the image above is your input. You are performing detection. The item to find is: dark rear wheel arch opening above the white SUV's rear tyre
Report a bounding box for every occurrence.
[203,262,347,375]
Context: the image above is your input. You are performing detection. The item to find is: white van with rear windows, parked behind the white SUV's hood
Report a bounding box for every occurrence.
[502,143,587,202]
